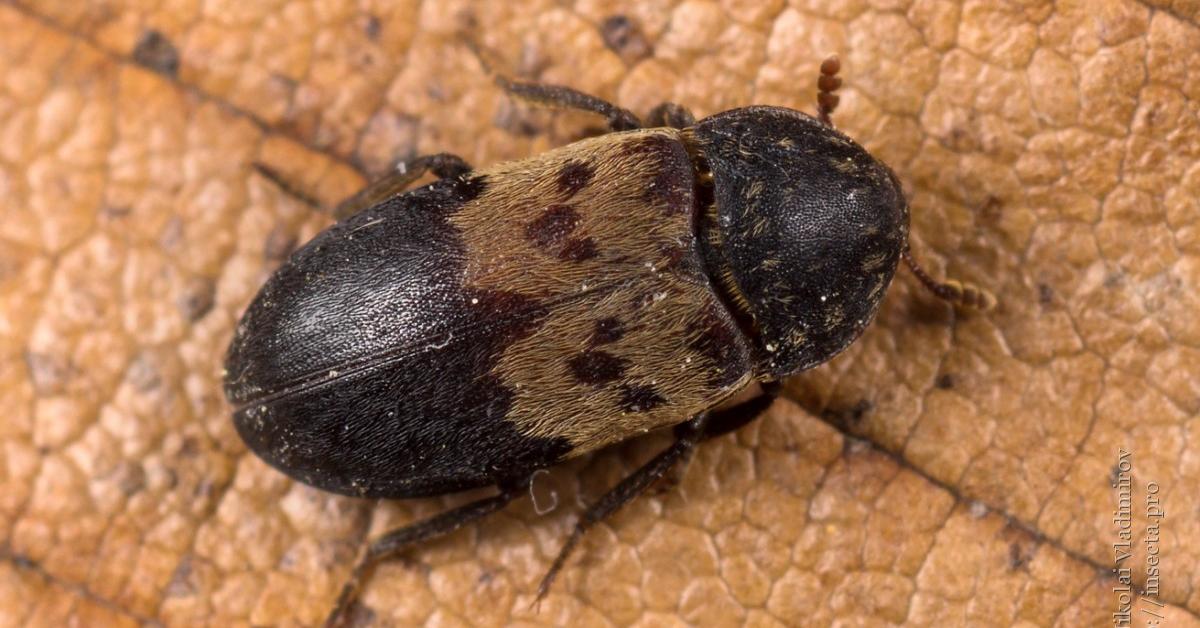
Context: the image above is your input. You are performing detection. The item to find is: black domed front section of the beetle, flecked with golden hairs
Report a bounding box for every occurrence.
[694,107,908,377]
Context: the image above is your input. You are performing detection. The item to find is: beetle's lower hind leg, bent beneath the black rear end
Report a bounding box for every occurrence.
[325,479,529,628]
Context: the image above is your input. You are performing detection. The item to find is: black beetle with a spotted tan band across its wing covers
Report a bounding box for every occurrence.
[224,56,995,623]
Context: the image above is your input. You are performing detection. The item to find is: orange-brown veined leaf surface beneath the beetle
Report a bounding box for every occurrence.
[0,0,1200,626]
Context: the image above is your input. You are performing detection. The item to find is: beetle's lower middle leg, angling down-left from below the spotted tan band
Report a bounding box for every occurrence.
[534,412,709,604]
